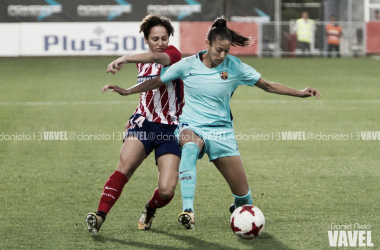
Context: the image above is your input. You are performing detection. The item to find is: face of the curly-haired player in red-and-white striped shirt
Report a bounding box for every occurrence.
[144,26,169,52]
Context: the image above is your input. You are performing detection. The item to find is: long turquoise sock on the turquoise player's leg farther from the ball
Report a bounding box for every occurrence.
[179,142,199,211]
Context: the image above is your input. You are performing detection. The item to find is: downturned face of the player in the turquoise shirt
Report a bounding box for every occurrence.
[206,39,231,68]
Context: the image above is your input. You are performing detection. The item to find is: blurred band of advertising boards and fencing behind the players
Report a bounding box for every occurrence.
[0,0,380,57]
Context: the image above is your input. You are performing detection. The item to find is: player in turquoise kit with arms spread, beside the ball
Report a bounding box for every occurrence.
[103,18,321,229]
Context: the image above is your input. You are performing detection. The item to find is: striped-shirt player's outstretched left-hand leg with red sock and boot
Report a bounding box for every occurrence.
[86,136,146,234]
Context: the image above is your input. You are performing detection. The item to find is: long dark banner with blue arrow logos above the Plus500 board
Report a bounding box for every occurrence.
[0,0,224,22]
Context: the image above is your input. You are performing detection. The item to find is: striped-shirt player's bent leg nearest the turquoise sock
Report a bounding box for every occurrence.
[137,152,180,230]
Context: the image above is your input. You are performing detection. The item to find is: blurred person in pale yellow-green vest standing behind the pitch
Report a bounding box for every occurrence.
[295,11,316,56]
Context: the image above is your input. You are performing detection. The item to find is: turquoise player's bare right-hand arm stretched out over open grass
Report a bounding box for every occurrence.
[255,78,321,99]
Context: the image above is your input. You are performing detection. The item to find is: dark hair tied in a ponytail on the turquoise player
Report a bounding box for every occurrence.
[207,17,253,47]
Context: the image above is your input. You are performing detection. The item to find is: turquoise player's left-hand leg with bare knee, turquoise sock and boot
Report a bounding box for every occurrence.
[178,129,205,229]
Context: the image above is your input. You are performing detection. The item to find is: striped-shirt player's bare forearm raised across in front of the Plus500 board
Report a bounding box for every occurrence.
[107,52,170,74]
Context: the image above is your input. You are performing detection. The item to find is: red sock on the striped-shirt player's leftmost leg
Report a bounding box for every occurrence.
[98,171,128,214]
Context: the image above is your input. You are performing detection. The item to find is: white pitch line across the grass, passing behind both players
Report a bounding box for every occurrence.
[0,100,380,106]
